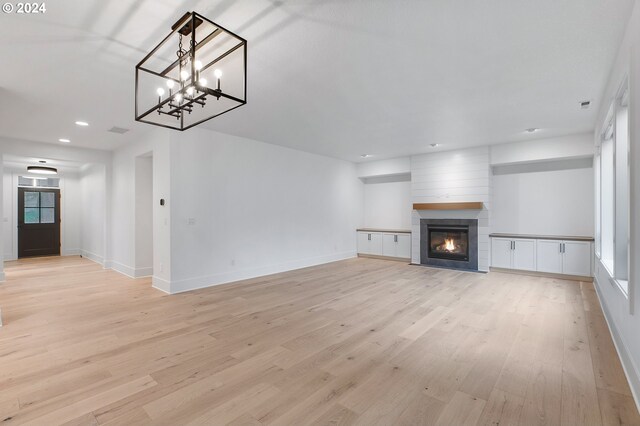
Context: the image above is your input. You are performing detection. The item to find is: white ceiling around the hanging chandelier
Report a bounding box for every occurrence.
[0,0,634,161]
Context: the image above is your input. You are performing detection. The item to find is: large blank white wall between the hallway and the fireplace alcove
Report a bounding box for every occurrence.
[168,129,363,293]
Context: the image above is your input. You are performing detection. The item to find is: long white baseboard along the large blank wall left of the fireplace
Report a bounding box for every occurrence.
[168,251,357,294]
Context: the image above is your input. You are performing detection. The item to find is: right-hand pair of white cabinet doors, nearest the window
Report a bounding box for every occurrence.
[537,240,591,277]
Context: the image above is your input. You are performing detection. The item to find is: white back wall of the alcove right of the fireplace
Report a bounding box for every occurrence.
[491,163,594,237]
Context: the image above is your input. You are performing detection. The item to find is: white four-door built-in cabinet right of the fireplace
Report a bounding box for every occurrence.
[491,237,591,277]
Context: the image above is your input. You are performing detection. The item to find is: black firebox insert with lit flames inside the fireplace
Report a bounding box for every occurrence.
[428,225,469,262]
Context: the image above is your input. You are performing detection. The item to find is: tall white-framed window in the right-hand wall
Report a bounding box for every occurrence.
[594,78,630,295]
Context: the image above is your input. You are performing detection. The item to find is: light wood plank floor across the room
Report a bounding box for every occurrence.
[0,257,640,426]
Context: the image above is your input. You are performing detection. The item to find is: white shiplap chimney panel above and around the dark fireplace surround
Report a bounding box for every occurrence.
[411,147,491,271]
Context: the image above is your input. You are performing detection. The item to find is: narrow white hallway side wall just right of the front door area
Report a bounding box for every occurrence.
[79,164,107,264]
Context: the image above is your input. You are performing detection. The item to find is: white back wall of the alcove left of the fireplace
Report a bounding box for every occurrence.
[363,178,412,230]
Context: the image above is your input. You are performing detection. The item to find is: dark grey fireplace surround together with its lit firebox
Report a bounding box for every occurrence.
[420,219,478,271]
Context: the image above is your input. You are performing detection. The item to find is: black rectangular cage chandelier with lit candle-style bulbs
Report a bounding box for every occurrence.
[136,12,247,130]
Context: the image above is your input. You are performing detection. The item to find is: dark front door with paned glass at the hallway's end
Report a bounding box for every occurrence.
[18,188,60,257]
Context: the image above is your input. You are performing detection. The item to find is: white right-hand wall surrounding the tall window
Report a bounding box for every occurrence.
[594,2,640,412]
